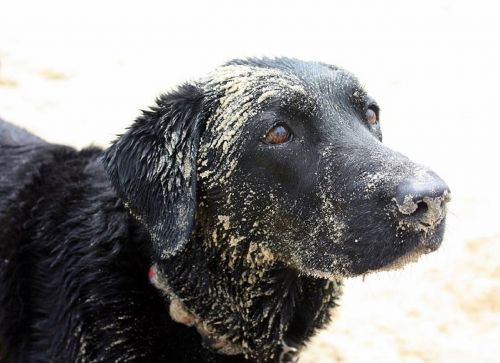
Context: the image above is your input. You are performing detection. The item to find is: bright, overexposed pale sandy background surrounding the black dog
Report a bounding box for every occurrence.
[0,0,500,363]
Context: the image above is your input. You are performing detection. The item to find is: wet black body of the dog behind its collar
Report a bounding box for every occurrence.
[0,123,248,363]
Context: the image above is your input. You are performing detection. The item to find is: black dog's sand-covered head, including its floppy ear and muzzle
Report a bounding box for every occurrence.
[105,59,449,277]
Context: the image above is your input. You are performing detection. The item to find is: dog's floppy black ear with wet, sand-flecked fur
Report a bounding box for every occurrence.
[104,85,204,258]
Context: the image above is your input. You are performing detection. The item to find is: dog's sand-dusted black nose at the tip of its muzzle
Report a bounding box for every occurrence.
[394,173,450,230]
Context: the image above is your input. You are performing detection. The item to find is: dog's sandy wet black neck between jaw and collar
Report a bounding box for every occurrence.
[150,219,340,362]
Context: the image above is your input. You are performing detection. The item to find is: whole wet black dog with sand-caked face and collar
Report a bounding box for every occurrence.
[0,59,449,362]
